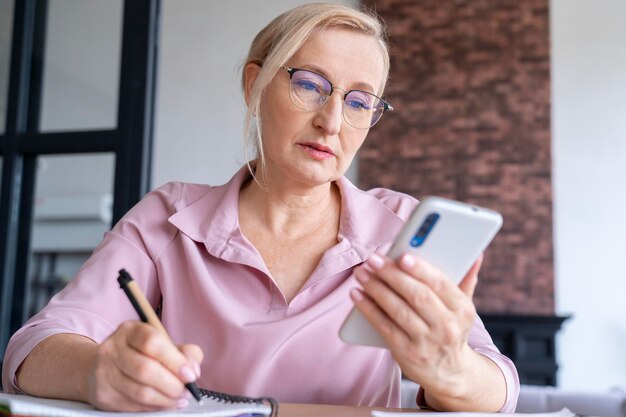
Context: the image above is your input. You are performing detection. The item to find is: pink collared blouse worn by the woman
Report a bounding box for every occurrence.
[2,167,519,411]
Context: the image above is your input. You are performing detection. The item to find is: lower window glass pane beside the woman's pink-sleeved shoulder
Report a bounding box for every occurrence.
[26,153,115,317]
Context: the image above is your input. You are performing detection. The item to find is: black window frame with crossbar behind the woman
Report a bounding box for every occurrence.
[0,0,160,364]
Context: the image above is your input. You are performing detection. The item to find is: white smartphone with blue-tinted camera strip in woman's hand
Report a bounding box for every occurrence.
[339,197,502,348]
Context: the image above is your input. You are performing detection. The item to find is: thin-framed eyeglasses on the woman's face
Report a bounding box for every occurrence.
[282,67,393,129]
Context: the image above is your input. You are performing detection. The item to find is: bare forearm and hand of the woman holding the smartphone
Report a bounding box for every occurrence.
[353,255,516,412]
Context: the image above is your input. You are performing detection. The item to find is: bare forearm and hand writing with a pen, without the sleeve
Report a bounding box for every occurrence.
[16,321,202,411]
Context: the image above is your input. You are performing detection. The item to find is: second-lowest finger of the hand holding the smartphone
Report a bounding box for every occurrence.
[354,267,428,342]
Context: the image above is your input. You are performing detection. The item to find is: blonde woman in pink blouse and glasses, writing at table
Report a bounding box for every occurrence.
[3,4,519,411]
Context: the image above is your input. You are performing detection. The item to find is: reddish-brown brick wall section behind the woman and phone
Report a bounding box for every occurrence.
[359,0,554,314]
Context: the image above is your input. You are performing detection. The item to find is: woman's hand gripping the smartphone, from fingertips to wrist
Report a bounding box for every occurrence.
[352,253,483,398]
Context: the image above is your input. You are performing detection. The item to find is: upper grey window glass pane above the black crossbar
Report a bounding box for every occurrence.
[39,0,123,132]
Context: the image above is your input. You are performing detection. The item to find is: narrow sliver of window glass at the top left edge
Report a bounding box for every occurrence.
[0,0,13,134]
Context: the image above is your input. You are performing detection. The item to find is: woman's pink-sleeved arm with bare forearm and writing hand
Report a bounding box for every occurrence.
[3,184,202,411]
